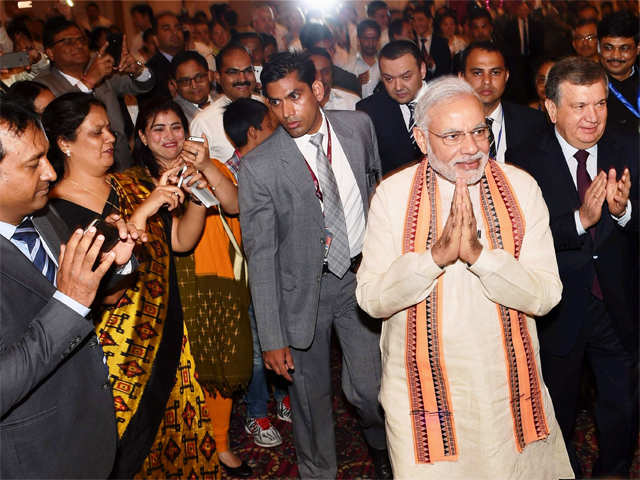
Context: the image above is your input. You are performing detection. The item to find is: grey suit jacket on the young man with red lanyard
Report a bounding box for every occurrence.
[238,111,380,350]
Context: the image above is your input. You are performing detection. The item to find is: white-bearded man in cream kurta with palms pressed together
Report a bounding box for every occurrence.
[356,77,573,480]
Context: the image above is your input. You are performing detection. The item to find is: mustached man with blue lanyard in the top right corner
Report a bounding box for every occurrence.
[598,10,640,135]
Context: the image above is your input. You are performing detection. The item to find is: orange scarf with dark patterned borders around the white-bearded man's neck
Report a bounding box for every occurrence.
[403,159,549,463]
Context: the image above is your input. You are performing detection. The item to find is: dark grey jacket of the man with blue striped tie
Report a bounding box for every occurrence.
[0,210,117,478]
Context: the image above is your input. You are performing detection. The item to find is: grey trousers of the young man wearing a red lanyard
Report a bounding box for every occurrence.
[289,271,387,479]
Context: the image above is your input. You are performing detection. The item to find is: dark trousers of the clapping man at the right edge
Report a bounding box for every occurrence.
[540,297,637,477]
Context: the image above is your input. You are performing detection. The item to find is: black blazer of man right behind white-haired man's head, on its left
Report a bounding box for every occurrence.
[356,88,422,175]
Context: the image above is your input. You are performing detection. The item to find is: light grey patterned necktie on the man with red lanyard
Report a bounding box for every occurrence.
[309,133,351,278]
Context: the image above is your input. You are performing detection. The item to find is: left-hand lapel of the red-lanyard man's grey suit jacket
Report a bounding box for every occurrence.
[274,126,324,228]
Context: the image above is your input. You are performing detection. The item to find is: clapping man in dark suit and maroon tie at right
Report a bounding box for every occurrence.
[507,57,639,477]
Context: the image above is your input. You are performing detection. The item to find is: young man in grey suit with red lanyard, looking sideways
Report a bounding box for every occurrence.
[238,52,391,478]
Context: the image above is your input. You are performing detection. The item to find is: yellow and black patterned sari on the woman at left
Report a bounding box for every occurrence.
[96,167,220,479]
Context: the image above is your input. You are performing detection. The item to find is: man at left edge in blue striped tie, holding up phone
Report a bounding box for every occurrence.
[0,101,139,478]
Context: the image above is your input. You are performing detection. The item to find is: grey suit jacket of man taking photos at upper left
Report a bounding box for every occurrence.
[34,65,155,171]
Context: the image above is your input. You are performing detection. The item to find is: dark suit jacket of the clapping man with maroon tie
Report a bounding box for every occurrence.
[507,128,640,355]
